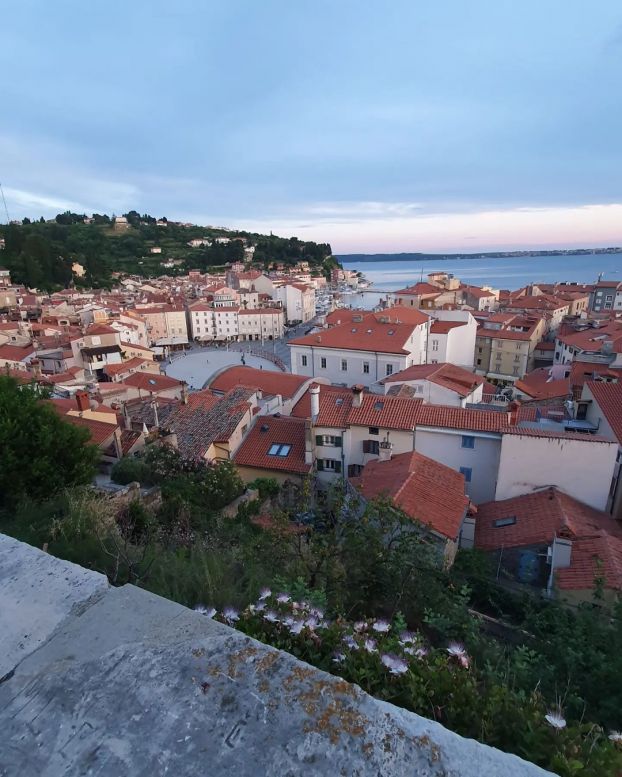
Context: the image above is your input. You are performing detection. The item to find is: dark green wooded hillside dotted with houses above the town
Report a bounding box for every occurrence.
[0,210,336,290]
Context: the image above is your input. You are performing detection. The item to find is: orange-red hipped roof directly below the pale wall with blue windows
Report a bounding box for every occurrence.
[354,451,469,540]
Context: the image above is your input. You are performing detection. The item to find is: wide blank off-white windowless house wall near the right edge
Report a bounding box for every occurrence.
[494,434,618,510]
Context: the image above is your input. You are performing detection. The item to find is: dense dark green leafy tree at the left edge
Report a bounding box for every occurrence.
[0,375,99,509]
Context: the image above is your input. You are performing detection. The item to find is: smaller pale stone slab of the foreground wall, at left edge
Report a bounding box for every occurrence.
[0,535,108,678]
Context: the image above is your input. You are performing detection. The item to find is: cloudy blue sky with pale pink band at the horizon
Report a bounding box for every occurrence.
[0,0,622,253]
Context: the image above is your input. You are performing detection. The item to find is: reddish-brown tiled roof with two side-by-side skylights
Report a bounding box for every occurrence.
[233,416,312,475]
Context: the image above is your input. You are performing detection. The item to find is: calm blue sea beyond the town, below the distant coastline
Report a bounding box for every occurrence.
[337,254,622,309]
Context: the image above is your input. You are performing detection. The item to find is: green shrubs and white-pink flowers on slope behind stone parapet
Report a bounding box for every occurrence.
[0,388,622,777]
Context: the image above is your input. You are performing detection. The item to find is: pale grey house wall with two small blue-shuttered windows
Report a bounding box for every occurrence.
[415,427,501,503]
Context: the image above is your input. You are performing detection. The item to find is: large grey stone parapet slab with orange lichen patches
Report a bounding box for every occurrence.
[0,535,546,777]
